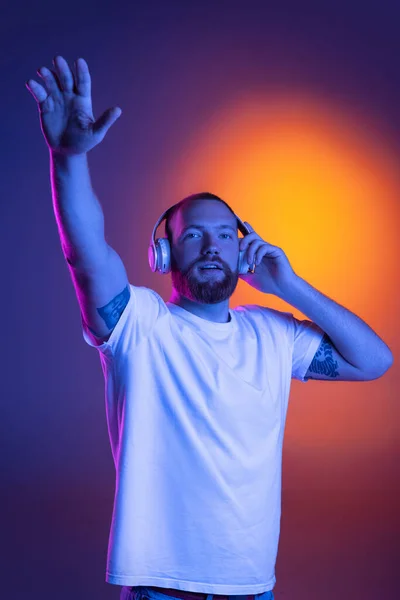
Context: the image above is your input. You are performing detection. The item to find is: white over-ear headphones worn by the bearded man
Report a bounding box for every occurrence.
[148,208,254,275]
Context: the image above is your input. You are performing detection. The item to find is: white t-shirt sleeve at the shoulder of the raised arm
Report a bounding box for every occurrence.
[81,283,164,355]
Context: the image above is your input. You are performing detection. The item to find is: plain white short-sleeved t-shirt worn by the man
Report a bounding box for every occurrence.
[82,284,324,595]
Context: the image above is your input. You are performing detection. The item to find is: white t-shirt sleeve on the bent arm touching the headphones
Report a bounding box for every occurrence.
[287,313,325,383]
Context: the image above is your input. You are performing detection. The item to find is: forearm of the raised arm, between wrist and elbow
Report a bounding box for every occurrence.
[50,152,107,266]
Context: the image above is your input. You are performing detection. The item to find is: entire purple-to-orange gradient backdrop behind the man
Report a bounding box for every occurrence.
[0,0,400,600]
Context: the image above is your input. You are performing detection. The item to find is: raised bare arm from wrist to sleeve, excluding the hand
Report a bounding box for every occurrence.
[50,152,130,343]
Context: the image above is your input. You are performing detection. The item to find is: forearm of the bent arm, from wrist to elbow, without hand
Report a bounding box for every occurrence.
[280,276,393,373]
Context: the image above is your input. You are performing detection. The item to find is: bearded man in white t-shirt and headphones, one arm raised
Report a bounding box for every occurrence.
[28,57,392,600]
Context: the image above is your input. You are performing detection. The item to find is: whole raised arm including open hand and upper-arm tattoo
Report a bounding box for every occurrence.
[26,55,130,340]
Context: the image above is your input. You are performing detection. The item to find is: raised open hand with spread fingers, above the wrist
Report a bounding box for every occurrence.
[25,56,122,156]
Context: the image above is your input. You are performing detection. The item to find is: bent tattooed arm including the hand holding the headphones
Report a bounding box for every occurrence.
[239,221,393,381]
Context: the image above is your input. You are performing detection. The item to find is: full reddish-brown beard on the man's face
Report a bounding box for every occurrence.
[171,257,239,304]
